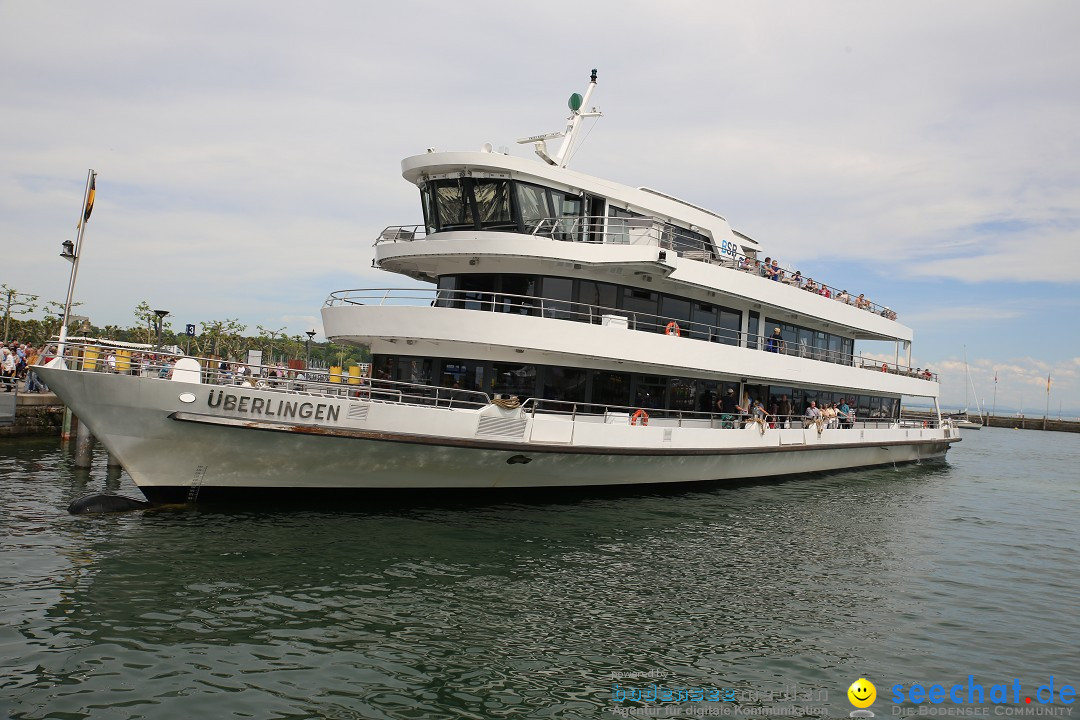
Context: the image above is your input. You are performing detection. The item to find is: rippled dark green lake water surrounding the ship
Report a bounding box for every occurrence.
[0,430,1080,718]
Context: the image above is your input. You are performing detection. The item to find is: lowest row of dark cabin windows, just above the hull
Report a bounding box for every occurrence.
[373,355,900,420]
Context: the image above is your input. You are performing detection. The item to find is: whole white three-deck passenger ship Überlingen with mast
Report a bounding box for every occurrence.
[41,70,959,502]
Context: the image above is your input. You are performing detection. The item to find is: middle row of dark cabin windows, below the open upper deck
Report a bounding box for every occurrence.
[435,273,854,365]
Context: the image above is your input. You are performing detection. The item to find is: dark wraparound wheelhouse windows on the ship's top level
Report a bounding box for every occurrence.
[420,177,714,252]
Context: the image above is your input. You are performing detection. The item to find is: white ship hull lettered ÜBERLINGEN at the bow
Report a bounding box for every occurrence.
[41,368,958,502]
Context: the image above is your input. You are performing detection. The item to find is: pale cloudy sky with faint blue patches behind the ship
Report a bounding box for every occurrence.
[0,0,1080,417]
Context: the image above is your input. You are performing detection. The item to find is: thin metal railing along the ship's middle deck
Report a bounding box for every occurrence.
[326,288,937,381]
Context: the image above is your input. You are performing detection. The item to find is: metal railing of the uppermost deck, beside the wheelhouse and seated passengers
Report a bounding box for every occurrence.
[375,216,896,320]
